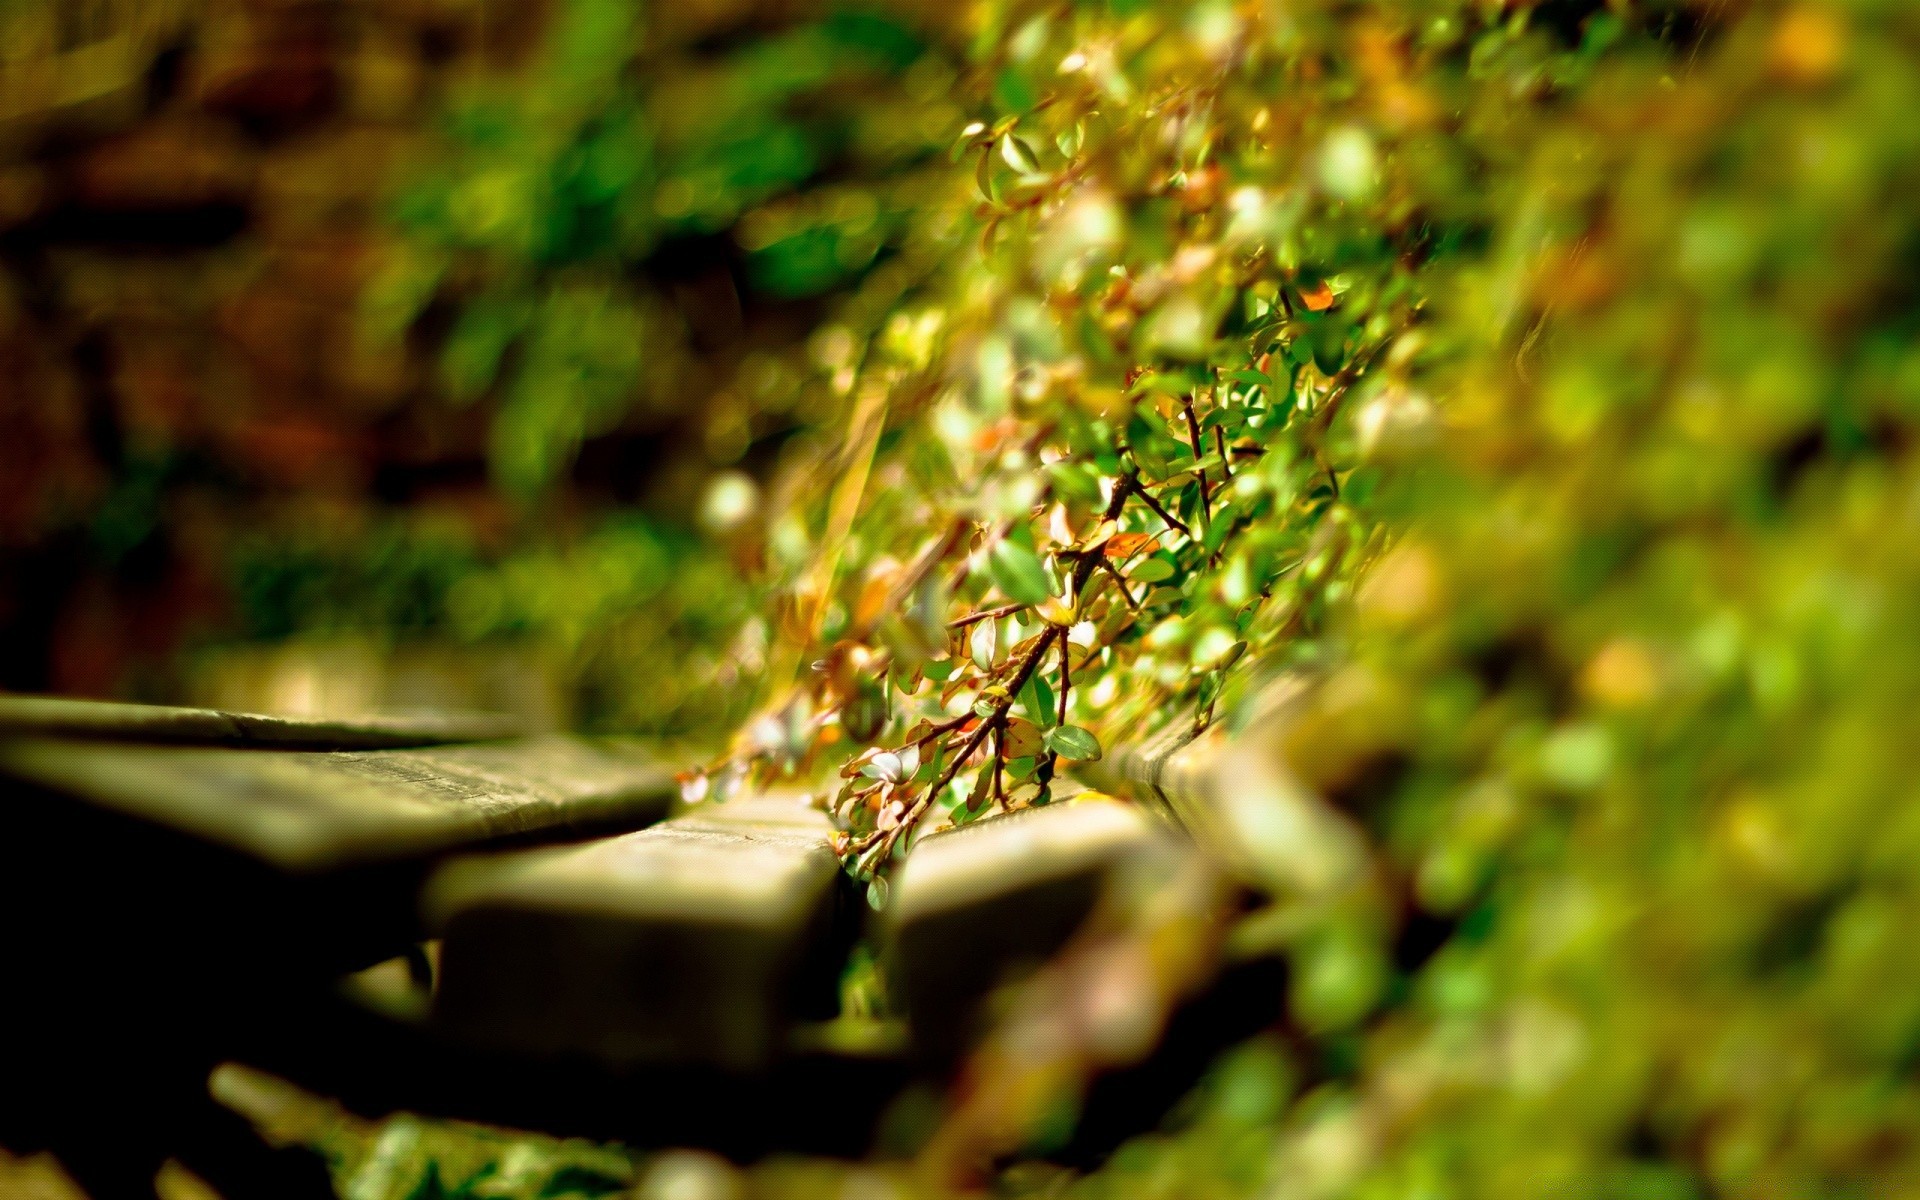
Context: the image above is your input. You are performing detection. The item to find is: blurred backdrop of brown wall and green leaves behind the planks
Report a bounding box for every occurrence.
[0,0,958,728]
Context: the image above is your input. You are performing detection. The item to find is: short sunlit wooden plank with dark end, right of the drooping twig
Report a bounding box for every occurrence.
[881,793,1175,1060]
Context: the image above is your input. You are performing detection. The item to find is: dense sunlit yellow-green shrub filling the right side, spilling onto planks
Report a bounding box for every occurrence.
[691,4,1920,1196]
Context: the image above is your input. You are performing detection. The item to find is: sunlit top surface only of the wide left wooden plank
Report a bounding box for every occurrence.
[0,737,674,874]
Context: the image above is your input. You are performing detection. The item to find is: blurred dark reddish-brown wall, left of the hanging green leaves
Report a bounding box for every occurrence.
[0,0,541,693]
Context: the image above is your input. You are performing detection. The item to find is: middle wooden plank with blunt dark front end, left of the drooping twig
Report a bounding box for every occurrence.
[428,797,845,1071]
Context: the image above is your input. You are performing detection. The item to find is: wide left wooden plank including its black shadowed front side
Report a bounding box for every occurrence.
[0,725,674,977]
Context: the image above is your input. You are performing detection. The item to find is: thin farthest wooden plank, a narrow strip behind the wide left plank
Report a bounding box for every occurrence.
[0,695,520,751]
